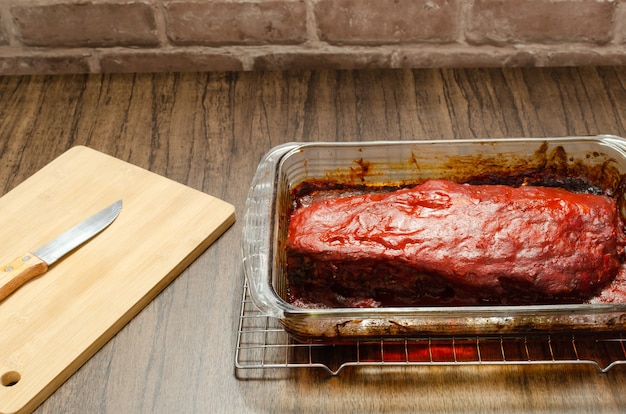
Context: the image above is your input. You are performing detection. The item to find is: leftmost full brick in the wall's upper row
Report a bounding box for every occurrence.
[11,2,159,47]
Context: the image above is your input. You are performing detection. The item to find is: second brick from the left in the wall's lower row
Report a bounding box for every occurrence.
[100,50,243,73]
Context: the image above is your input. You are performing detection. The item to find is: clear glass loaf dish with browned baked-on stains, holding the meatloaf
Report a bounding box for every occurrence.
[242,135,626,342]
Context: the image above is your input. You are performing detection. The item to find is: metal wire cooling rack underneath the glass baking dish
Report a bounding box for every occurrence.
[235,283,626,378]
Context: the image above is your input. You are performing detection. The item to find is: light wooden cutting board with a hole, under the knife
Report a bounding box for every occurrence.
[0,146,235,414]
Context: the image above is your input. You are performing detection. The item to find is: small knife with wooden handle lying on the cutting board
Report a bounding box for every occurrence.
[0,200,122,302]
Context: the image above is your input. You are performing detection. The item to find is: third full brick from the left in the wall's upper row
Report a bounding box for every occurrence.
[315,0,458,45]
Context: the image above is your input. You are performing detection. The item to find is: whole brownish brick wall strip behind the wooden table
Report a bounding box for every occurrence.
[0,0,626,75]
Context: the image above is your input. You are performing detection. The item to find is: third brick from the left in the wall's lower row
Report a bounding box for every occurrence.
[253,50,391,70]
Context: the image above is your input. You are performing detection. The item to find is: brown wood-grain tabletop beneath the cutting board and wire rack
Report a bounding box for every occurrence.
[0,67,626,413]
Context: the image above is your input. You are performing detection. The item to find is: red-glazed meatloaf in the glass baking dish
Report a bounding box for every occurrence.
[286,180,623,307]
